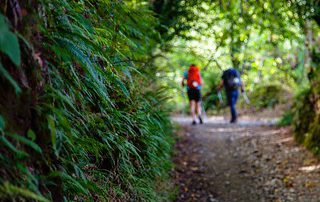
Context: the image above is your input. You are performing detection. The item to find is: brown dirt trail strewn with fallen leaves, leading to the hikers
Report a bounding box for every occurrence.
[172,117,320,202]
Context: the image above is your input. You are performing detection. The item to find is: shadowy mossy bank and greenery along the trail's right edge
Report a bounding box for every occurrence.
[286,1,320,155]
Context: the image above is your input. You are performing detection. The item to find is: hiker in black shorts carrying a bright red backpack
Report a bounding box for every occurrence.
[182,64,203,125]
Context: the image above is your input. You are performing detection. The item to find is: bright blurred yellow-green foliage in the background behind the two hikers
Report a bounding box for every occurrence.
[154,1,307,115]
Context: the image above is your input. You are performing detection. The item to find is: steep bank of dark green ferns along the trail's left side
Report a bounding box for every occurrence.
[0,0,172,201]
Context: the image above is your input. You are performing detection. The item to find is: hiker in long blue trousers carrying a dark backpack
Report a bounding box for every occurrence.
[218,68,244,123]
